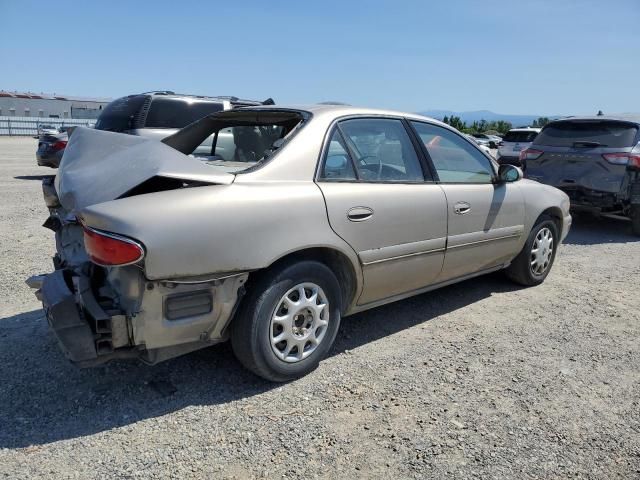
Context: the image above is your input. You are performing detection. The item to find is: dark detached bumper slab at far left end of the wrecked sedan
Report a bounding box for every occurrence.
[41,270,98,363]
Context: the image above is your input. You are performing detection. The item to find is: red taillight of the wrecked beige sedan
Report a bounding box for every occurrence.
[84,227,144,266]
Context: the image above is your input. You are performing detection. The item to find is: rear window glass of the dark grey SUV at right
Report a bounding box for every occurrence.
[534,121,638,147]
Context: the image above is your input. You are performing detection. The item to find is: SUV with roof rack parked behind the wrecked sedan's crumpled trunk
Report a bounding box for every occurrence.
[38,91,273,168]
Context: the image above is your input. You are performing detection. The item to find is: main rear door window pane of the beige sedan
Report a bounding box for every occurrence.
[339,118,424,182]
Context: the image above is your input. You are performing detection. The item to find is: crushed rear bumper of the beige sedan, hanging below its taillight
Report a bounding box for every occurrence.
[33,269,248,367]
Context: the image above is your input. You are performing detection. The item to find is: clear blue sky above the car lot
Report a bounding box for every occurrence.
[0,0,640,115]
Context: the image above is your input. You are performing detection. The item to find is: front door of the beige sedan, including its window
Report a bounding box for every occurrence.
[411,121,524,281]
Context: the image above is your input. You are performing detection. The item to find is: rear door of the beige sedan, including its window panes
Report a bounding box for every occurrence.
[318,117,447,305]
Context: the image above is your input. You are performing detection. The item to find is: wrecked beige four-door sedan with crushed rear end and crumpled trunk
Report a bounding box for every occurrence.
[29,105,571,381]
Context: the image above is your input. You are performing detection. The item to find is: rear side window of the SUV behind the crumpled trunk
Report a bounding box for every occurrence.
[145,97,224,128]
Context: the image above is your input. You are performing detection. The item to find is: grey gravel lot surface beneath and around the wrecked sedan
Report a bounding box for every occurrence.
[0,138,640,479]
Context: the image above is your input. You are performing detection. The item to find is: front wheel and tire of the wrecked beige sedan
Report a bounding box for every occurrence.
[506,215,560,287]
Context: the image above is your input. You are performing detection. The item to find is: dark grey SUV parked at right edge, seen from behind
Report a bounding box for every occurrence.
[520,116,640,235]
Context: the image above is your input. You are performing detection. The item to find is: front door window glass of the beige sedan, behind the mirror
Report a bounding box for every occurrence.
[411,122,494,183]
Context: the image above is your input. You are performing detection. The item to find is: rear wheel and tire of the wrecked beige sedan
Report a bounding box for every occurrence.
[231,261,342,382]
